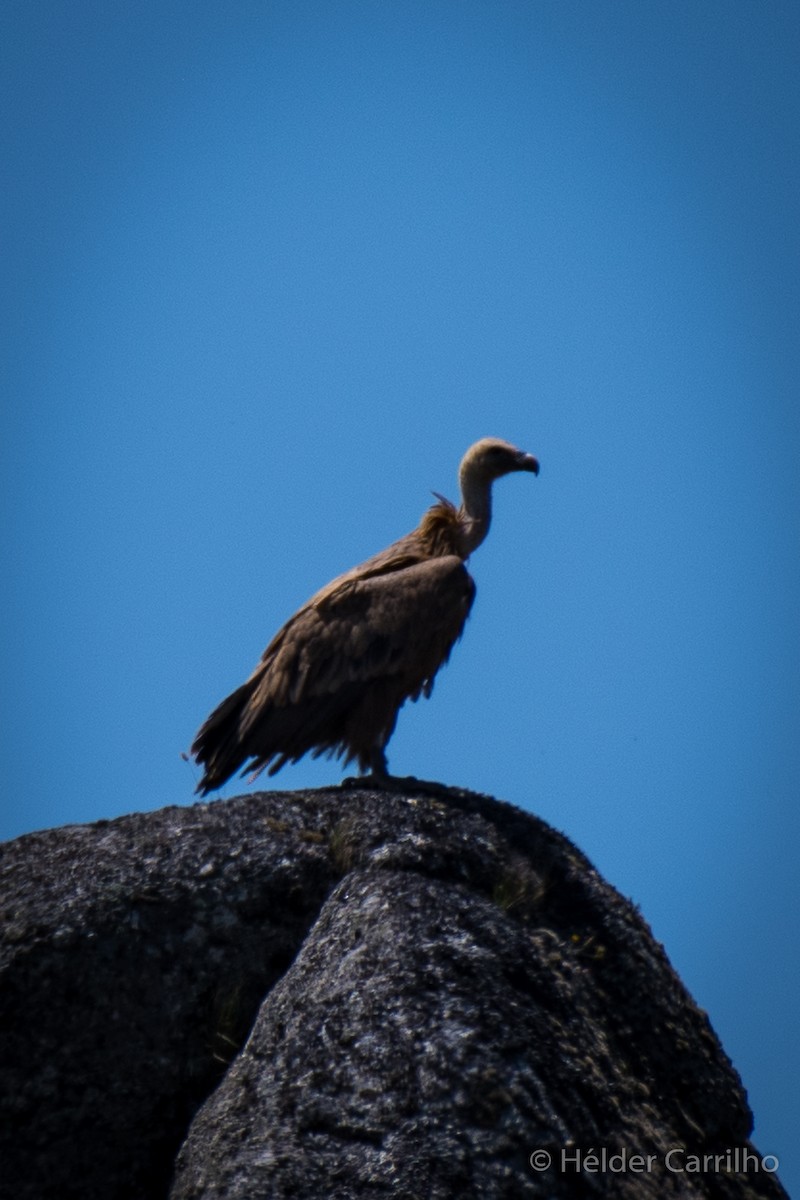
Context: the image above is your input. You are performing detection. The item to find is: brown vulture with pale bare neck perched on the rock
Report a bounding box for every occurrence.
[191,438,539,796]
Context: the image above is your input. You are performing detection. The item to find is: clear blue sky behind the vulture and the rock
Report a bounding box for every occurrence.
[0,0,800,1184]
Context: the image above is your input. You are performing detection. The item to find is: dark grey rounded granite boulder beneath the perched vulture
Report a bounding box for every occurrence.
[0,785,784,1200]
